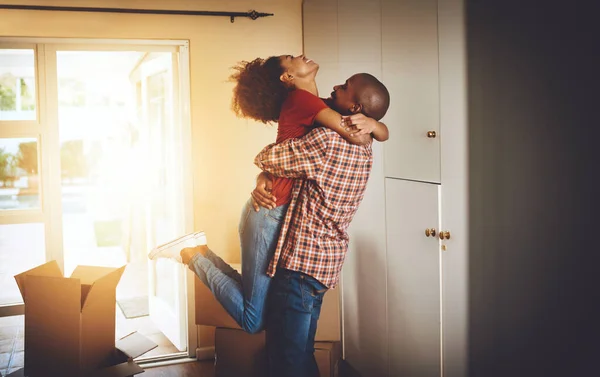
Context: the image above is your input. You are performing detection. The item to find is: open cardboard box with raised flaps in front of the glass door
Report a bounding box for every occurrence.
[15,261,156,377]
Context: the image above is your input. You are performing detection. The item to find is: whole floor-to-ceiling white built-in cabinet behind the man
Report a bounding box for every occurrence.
[303,0,468,377]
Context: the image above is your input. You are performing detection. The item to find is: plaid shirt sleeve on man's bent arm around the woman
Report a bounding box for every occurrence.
[254,128,332,179]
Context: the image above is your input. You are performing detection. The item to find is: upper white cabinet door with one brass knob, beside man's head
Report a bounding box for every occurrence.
[381,0,440,183]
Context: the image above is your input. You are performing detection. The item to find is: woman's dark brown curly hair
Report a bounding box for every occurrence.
[229,56,288,123]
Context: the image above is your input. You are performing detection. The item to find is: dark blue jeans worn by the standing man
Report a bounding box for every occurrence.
[266,268,327,377]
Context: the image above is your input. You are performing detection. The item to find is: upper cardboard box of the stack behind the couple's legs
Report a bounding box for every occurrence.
[195,264,341,341]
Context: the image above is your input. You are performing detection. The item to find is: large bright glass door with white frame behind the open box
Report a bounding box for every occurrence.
[0,39,196,357]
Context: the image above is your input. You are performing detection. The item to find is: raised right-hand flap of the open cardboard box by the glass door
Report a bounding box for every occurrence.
[81,266,126,311]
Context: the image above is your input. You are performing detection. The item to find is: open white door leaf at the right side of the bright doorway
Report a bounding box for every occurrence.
[131,53,191,351]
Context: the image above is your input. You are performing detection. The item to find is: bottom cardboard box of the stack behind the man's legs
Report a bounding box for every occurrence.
[215,328,342,377]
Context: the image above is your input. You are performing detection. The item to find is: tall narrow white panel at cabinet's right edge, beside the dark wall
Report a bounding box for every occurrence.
[438,0,469,377]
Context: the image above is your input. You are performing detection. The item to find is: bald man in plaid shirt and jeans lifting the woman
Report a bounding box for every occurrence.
[252,74,389,377]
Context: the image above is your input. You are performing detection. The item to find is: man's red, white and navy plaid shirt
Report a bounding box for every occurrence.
[254,127,373,288]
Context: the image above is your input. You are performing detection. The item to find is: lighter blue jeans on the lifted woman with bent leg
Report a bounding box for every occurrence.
[189,199,288,334]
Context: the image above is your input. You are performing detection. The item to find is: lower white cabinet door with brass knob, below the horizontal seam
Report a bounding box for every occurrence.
[386,179,441,377]
